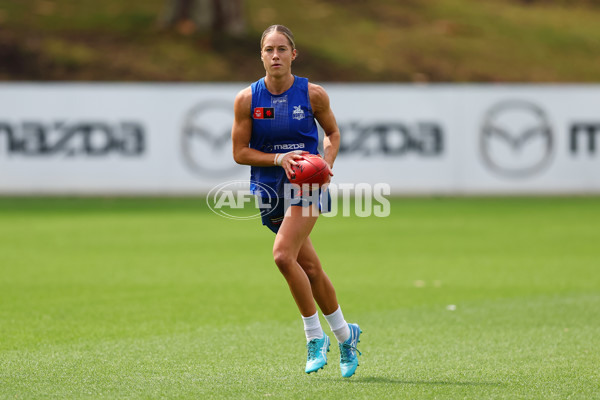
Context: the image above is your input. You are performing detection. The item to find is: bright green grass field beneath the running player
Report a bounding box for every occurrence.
[0,197,600,399]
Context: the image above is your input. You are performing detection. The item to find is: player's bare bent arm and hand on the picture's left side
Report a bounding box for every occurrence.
[231,87,302,178]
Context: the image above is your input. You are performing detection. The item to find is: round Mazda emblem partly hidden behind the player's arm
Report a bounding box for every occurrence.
[181,100,243,177]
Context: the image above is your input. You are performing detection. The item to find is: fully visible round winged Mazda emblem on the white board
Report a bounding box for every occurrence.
[479,100,554,178]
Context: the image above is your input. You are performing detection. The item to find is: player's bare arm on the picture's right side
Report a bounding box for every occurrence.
[308,83,340,175]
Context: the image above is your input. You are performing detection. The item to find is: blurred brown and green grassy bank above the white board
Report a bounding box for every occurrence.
[0,0,600,82]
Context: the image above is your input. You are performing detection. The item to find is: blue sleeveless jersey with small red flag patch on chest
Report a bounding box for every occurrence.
[250,76,319,197]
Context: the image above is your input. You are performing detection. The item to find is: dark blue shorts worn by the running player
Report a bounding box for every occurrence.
[258,189,331,233]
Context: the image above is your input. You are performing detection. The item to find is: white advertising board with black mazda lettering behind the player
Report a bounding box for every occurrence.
[0,83,600,195]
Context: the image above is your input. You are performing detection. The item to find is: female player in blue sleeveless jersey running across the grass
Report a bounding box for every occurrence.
[231,25,361,377]
